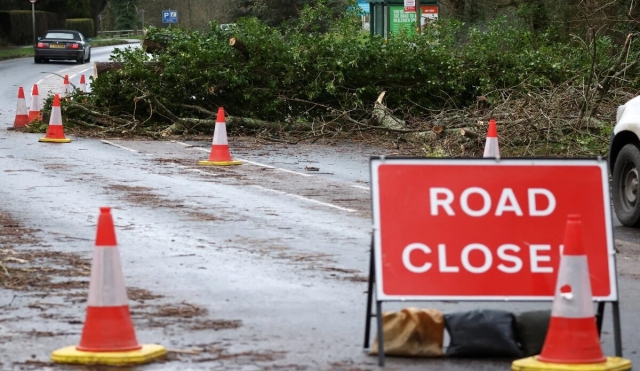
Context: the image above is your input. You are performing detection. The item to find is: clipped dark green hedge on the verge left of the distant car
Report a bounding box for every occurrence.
[0,10,60,45]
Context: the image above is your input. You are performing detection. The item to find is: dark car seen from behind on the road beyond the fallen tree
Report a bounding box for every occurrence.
[33,30,91,64]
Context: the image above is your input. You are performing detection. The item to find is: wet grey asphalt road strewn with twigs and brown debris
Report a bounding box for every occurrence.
[0,48,640,370]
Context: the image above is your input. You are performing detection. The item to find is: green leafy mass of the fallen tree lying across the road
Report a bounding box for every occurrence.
[87,1,632,127]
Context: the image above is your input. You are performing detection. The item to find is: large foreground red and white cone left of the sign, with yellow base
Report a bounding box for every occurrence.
[51,207,167,366]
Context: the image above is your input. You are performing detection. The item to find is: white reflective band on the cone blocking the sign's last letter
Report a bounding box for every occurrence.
[551,255,595,318]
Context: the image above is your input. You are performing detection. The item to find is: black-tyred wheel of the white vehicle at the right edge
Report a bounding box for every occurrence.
[613,144,640,227]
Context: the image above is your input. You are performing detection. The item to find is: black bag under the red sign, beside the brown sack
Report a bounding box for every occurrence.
[444,309,522,358]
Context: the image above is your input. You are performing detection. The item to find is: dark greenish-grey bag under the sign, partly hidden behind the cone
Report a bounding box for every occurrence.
[515,310,551,357]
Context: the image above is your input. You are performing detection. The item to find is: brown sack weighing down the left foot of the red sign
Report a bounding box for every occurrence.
[370,308,444,357]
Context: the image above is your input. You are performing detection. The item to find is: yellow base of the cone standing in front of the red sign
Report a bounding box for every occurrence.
[511,356,631,371]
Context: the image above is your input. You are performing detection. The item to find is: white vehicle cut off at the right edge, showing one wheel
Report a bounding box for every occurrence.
[609,96,640,227]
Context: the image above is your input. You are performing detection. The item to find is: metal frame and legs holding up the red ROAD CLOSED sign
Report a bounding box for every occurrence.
[364,156,622,366]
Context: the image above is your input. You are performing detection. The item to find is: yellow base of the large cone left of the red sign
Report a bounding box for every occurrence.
[51,344,167,366]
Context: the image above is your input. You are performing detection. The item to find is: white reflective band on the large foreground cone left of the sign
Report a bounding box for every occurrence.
[87,247,129,307]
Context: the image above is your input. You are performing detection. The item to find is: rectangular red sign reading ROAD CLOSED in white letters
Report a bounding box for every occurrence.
[371,158,617,301]
